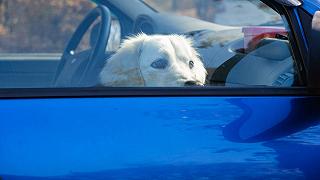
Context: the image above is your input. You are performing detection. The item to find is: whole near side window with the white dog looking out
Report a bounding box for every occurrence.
[0,0,303,88]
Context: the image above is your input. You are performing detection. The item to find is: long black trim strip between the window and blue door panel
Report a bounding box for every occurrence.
[0,87,312,99]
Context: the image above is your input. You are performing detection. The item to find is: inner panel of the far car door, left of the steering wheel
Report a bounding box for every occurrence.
[0,54,61,88]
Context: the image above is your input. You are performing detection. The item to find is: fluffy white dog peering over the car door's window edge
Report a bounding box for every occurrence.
[100,34,207,87]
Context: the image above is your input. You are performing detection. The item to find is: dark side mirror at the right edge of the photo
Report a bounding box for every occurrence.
[308,11,320,89]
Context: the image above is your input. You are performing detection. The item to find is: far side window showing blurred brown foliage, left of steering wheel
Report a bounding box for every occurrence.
[0,0,95,53]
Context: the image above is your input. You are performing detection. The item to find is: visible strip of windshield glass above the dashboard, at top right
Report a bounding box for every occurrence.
[143,0,282,26]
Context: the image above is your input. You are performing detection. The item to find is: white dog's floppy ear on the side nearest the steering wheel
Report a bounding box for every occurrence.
[100,34,147,87]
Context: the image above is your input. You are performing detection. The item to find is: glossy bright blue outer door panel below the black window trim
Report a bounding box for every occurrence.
[0,97,320,179]
